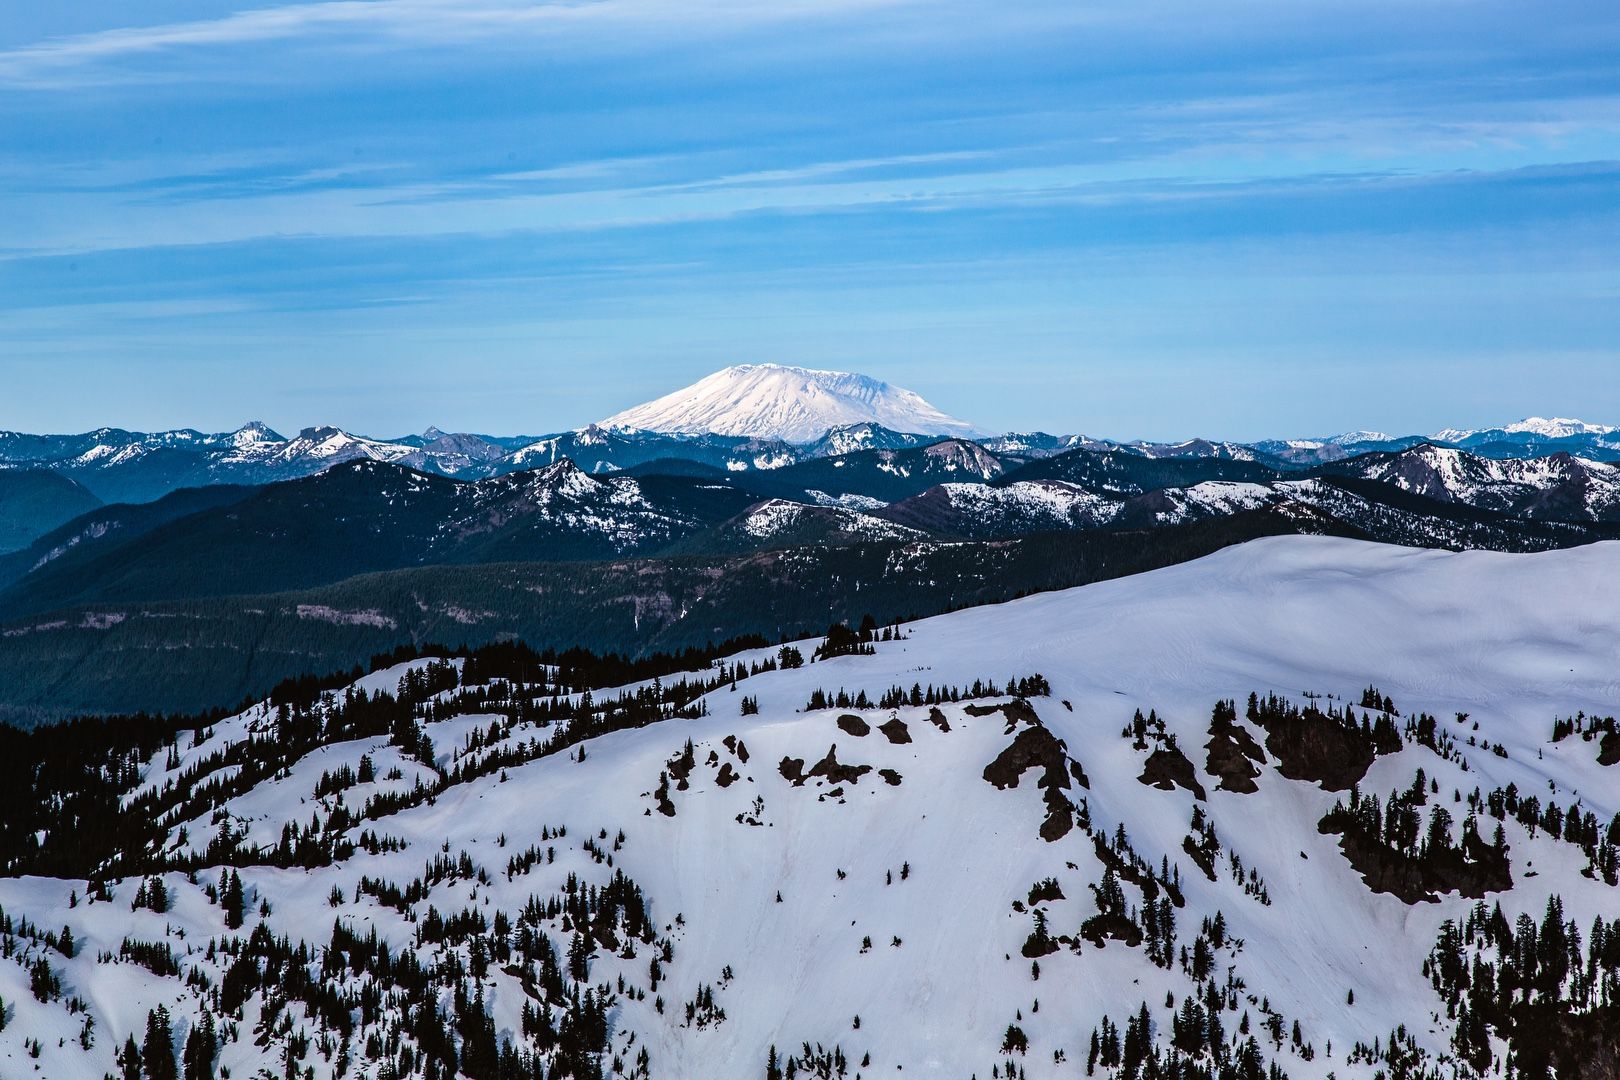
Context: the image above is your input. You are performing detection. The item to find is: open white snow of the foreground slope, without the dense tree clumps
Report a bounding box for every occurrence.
[0,538,1620,1078]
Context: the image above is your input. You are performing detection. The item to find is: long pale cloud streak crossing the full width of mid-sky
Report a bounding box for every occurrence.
[8,128,1620,259]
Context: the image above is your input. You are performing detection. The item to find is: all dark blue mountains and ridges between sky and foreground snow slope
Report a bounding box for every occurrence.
[0,369,1620,716]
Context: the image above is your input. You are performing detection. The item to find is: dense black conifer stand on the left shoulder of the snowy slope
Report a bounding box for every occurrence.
[0,638,770,878]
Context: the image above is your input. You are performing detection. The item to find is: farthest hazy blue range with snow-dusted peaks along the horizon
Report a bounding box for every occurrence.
[0,411,1620,552]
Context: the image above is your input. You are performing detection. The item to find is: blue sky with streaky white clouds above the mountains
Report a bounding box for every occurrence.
[0,0,1620,439]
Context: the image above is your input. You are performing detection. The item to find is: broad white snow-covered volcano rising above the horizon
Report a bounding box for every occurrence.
[603,364,983,442]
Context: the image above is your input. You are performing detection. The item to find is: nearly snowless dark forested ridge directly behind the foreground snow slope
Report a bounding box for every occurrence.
[0,510,1349,724]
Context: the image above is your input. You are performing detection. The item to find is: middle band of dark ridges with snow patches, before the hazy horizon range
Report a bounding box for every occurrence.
[0,439,1620,637]
